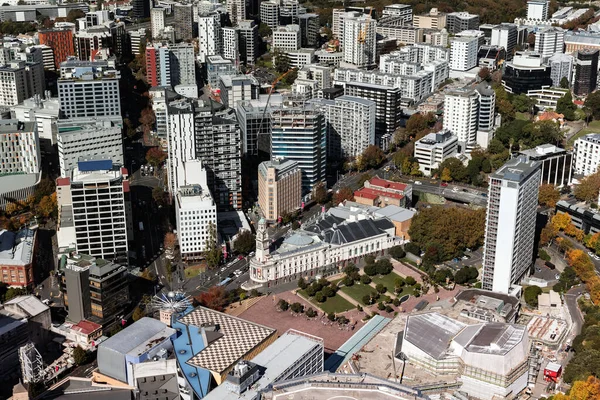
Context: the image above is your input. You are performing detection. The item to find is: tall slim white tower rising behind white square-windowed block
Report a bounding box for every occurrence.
[167,100,196,195]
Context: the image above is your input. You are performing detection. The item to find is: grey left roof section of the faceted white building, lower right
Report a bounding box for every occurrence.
[404,312,466,360]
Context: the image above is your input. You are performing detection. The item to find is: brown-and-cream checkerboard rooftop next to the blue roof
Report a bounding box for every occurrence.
[179,307,276,373]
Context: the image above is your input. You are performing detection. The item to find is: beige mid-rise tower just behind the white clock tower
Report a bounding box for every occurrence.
[258,159,302,222]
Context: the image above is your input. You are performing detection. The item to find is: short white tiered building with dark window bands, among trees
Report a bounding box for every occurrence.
[414,130,458,176]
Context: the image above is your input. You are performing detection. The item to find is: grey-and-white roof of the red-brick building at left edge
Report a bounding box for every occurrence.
[0,228,36,266]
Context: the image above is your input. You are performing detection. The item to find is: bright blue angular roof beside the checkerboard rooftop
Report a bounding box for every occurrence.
[171,307,212,399]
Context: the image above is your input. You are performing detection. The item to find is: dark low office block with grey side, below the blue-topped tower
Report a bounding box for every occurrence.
[61,253,129,329]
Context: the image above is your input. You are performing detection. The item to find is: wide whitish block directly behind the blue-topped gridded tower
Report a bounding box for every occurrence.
[56,117,124,177]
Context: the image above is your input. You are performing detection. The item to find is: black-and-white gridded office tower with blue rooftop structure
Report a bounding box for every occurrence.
[56,160,130,265]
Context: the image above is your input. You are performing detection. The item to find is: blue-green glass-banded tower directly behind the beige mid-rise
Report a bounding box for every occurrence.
[271,104,327,194]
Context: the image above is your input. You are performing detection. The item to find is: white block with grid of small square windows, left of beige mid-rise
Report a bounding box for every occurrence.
[175,160,217,260]
